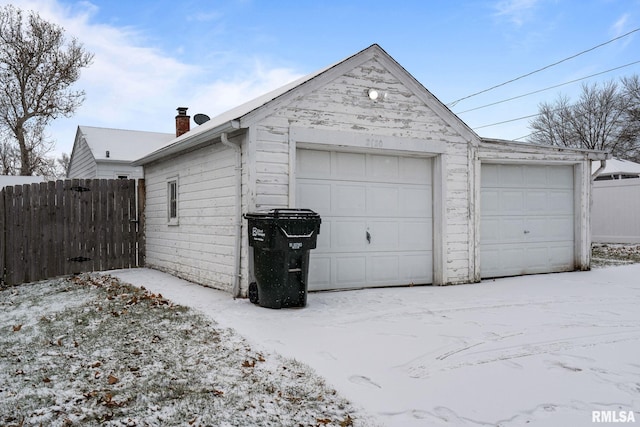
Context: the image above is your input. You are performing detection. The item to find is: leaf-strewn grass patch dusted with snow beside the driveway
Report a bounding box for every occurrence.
[0,274,357,427]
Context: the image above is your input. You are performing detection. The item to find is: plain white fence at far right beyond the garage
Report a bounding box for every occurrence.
[591,178,640,243]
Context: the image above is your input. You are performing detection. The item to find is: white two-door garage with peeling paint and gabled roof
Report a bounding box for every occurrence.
[135,44,607,296]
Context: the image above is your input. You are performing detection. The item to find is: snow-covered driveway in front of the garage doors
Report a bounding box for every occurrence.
[111,264,640,426]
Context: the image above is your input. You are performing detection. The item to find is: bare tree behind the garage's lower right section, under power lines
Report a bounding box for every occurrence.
[529,80,638,158]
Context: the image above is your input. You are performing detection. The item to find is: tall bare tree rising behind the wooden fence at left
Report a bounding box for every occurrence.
[0,5,93,175]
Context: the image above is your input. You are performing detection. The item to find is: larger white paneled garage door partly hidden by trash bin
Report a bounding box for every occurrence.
[296,149,433,290]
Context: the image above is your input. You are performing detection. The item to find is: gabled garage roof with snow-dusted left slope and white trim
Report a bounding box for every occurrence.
[133,44,477,165]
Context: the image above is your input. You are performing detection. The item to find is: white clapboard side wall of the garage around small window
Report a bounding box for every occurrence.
[146,142,237,291]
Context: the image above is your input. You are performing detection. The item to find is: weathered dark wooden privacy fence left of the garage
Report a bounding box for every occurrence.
[0,179,145,285]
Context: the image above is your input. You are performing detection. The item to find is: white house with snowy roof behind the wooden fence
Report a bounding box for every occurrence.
[67,126,175,179]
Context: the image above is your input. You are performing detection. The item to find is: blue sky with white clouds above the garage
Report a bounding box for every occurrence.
[5,0,640,154]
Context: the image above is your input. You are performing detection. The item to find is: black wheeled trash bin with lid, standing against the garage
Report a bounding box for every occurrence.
[244,209,321,308]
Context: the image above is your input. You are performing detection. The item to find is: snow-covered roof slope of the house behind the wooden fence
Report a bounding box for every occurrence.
[78,126,175,162]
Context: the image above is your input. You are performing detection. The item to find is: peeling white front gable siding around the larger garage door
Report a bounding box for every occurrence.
[252,58,471,283]
